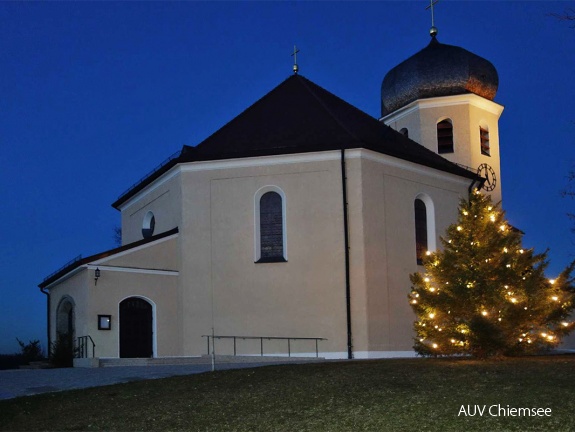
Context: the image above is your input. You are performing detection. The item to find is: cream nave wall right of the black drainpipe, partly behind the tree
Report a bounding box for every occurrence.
[352,150,469,357]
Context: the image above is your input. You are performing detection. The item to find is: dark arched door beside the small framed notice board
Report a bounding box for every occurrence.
[120,297,154,358]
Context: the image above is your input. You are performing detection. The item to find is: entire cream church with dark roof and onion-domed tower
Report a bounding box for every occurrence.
[39,28,503,358]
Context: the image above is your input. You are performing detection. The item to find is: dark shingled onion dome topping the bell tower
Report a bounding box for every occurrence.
[381,35,499,116]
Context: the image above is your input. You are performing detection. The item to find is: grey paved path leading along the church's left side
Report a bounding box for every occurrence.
[0,362,278,399]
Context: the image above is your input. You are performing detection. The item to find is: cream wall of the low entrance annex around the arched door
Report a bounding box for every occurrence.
[49,237,182,357]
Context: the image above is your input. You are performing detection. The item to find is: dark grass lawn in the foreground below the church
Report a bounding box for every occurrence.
[0,356,575,432]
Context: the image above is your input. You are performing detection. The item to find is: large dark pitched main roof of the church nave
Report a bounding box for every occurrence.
[112,75,476,208]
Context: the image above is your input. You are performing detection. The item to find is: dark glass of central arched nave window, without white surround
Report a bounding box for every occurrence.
[260,192,284,261]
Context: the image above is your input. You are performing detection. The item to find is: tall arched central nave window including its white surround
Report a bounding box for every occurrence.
[256,188,286,263]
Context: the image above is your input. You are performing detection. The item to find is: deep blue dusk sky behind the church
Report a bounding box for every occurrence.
[0,0,575,353]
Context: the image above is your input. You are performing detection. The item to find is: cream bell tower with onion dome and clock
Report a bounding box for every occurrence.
[381,31,503,202]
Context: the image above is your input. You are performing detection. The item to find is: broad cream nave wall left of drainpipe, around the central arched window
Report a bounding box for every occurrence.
[176,152,346,355]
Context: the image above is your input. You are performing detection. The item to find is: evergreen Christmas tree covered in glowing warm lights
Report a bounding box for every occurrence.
[409,192,575,357]
